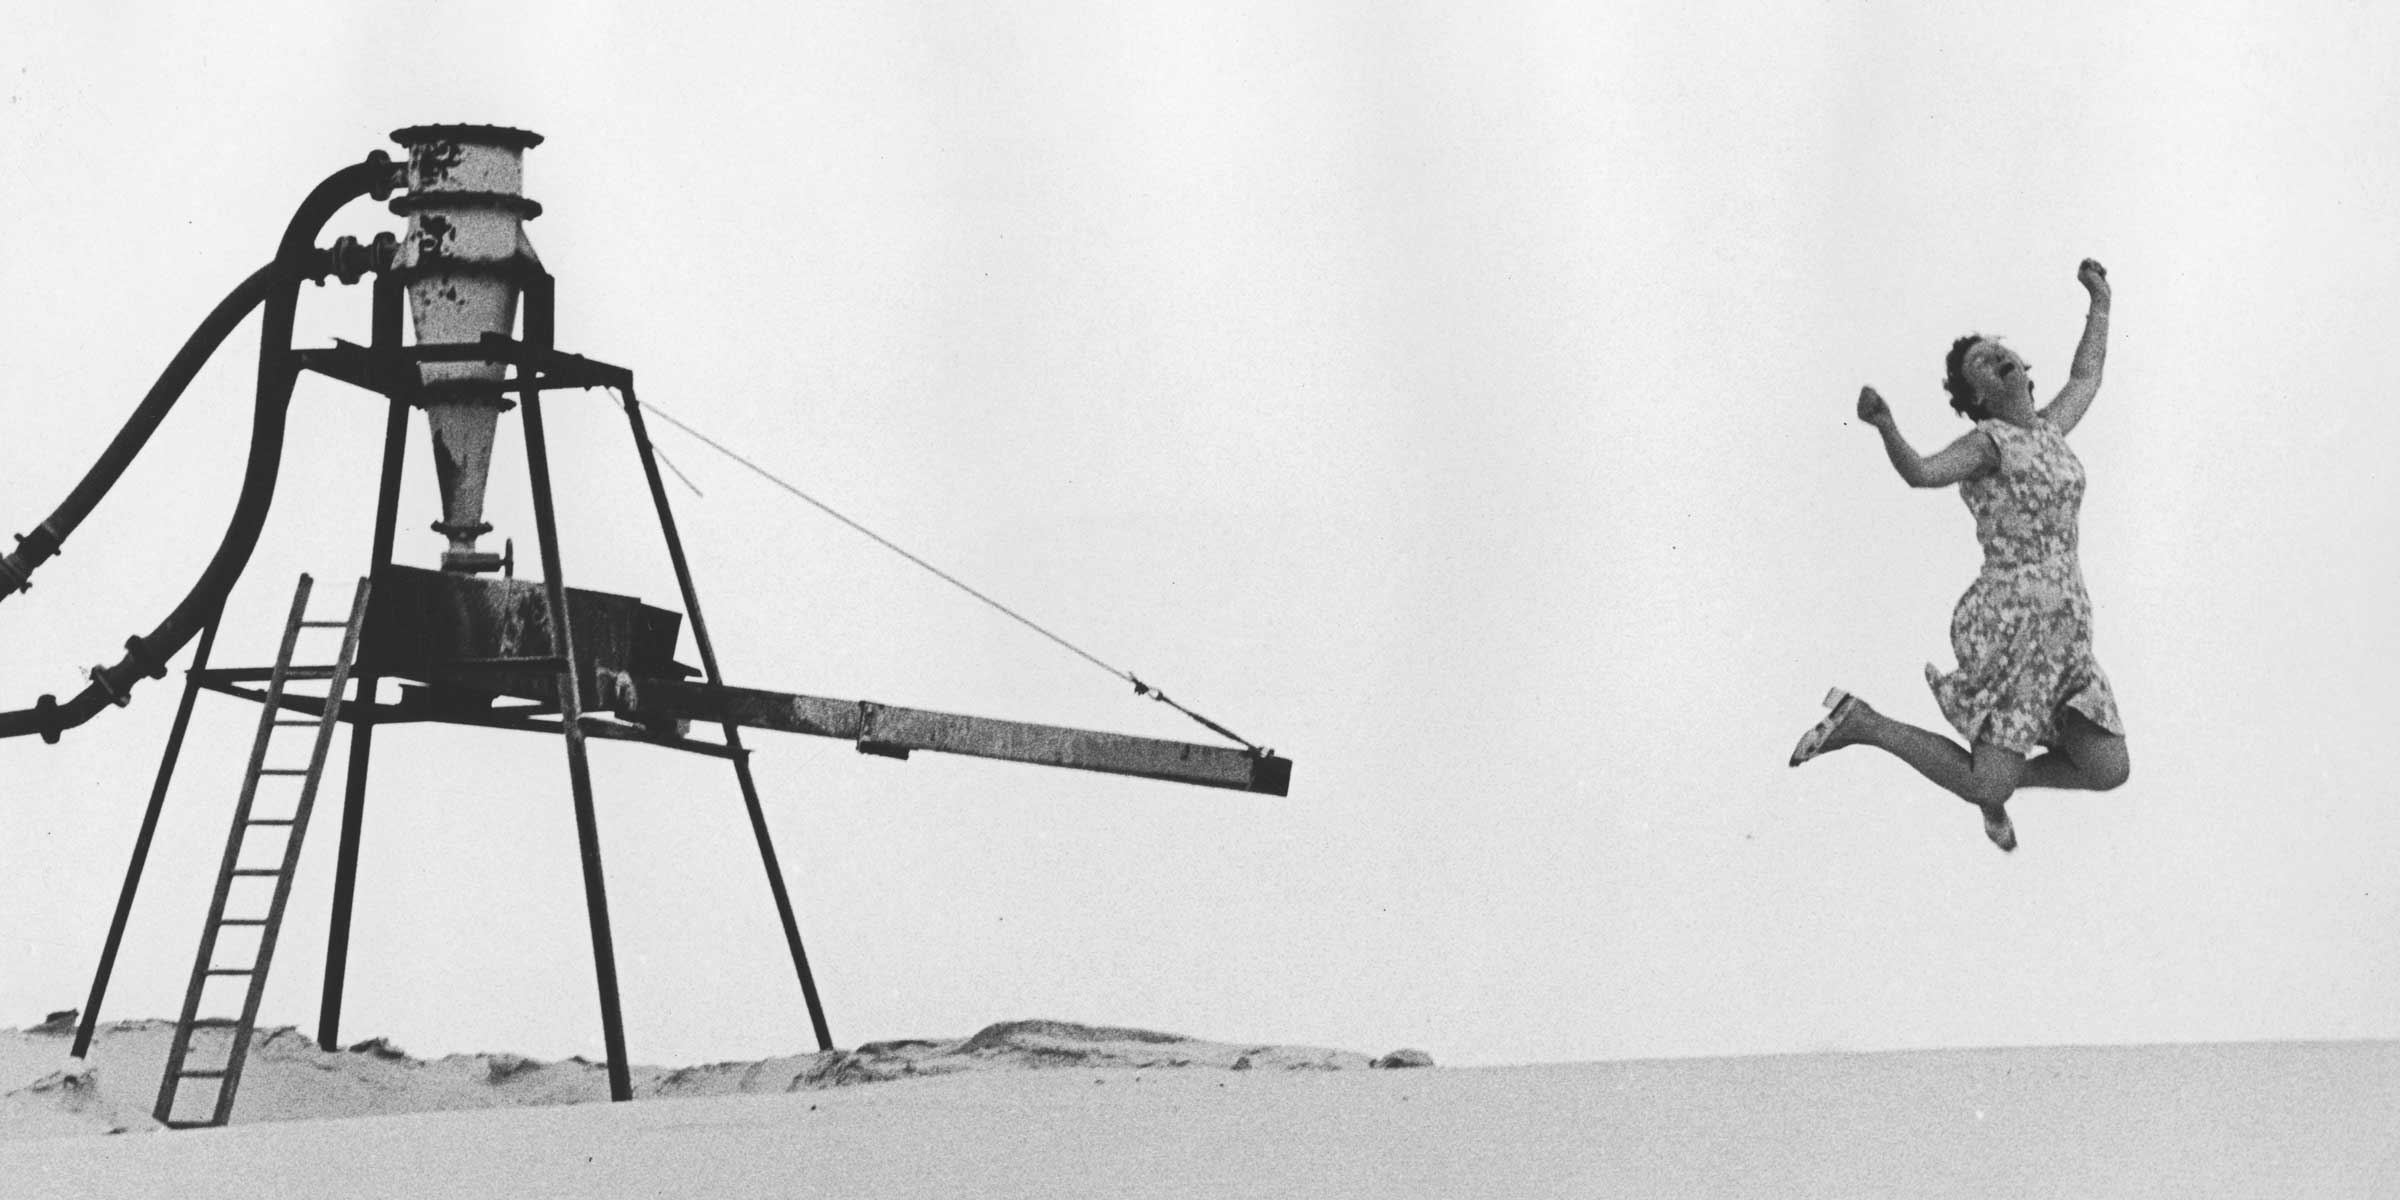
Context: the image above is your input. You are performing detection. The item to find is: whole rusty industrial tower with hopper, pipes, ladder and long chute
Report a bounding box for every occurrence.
[0,125,1291,1128]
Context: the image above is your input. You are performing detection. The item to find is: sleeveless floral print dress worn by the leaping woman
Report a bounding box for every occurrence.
[1925,420,2124,754]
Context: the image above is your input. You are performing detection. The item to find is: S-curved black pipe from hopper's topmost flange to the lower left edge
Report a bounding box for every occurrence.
[0,151,398,742]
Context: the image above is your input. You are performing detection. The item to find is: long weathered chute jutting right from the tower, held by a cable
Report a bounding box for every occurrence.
[600,670,1291,797]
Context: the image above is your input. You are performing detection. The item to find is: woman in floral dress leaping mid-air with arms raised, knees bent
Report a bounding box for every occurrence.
[1790,259,2129,850]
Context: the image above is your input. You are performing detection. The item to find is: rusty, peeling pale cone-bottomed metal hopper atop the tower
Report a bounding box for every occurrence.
[391,125,542,574]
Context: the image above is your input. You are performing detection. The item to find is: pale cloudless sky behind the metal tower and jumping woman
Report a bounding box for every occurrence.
[0,2,2400,1063]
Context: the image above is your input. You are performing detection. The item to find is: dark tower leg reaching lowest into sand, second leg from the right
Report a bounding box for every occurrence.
[518,276,634,1099]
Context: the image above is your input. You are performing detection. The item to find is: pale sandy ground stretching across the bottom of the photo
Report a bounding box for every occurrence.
[0,1022,2400,1198]
